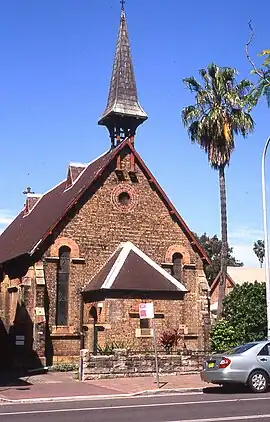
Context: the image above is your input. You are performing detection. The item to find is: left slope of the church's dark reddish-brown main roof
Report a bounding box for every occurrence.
[0,144,121,263]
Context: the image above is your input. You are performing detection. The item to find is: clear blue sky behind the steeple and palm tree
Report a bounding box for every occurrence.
[0,0,270,265]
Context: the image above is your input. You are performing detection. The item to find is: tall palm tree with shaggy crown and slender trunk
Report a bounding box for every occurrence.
[182,64,254,318]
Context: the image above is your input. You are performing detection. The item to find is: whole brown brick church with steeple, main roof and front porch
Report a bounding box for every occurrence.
[0,5,210,365]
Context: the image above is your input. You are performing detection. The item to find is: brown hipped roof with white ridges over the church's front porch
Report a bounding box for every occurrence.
[84,242,187,292]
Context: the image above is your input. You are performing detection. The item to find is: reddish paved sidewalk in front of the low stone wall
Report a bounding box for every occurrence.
[0,372,207,403]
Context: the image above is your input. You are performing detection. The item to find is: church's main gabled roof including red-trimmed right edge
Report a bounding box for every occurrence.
[0,139,210,263]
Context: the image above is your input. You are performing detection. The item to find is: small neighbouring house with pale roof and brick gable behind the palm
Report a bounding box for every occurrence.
[210,267,265,315]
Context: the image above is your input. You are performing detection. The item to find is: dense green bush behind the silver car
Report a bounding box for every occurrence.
[211,282,267,351]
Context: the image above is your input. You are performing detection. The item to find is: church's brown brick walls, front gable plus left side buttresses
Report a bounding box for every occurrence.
[2,148,209,363]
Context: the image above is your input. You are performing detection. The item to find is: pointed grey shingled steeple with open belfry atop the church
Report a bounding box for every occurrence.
[98,0,147,147]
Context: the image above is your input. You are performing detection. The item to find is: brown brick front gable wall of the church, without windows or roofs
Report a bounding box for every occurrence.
[45,148,208,355]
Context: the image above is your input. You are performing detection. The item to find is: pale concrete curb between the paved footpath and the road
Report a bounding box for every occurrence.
[0,387,204,405]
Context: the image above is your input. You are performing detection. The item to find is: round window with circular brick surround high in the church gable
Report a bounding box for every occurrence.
[111,183,138,212]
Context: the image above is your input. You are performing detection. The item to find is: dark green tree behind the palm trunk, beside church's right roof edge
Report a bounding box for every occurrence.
[194,233,243,286]
